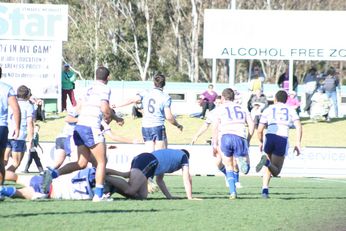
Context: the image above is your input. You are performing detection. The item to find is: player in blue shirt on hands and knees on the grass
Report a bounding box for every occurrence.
[106,149,197,200]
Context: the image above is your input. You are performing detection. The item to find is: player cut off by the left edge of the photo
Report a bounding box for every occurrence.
[0,67,20,191]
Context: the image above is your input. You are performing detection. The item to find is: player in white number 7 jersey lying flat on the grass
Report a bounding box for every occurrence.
[0,168,102,200]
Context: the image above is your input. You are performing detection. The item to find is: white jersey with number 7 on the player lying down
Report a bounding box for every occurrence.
[50,168,95,200]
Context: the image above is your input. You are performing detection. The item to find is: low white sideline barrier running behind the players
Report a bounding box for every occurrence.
[18,142,346,178]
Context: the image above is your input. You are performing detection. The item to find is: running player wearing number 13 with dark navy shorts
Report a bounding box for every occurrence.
[256,90,303,198]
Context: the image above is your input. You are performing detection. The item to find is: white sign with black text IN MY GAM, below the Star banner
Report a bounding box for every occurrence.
[0,40,62,98]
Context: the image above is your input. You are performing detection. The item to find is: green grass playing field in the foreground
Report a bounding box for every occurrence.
[0,176,346,231]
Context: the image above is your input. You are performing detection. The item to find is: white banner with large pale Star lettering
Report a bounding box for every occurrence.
[0,3,68,42]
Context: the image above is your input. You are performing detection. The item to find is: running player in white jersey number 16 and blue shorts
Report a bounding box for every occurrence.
[212,88,254,199]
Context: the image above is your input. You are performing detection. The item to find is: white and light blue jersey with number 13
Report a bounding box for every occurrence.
[260,103,299,137]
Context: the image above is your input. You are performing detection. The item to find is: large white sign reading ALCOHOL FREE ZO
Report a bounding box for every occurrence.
[203,9,346,60]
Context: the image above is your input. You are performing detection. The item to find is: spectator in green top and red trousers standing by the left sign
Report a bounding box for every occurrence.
[61,64,77,111]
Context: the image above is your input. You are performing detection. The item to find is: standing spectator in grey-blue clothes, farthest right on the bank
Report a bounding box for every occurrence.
[323,67,340,117]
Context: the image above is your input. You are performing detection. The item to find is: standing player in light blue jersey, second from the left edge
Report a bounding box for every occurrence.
[4,85,35,175]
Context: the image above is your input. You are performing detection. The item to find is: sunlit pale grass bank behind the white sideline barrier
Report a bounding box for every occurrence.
[39,114,346,147]
